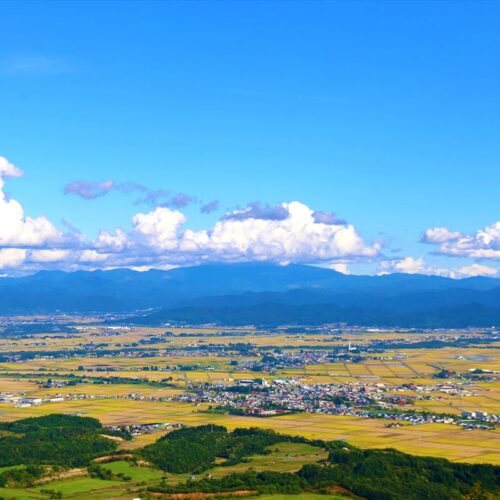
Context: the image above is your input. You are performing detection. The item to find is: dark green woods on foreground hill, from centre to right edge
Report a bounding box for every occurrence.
[148,426,500,500]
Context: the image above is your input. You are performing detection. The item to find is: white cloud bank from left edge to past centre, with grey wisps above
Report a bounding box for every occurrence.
[0,158,380,271]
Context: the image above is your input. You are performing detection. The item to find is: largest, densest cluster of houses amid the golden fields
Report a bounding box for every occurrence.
[173,378,498,428]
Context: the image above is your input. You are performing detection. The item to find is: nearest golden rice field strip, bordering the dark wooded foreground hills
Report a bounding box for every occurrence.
[0,392,500,464]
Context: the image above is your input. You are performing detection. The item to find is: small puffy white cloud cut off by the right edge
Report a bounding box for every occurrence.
[423,221,500,260]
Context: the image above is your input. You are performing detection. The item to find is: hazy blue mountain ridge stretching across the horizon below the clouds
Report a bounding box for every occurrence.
[0,263,500,326]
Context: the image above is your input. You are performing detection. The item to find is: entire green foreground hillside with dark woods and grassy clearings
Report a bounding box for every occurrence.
[0,415,500,500]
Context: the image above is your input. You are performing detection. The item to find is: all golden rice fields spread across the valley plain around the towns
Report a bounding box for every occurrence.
[0,323,500,464]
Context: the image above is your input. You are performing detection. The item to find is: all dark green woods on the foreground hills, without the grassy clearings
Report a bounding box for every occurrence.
[0,415,500,500]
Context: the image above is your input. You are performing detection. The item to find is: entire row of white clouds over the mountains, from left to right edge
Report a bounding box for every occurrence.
[0,157,500,278]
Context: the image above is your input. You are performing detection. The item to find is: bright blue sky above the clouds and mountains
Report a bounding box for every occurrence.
[0,1,500,275]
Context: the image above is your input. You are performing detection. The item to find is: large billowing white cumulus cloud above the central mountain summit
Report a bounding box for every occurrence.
[97,202,380,264]
